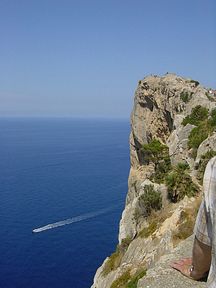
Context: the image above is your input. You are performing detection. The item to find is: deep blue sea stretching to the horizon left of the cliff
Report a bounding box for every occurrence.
[0,118,130,288]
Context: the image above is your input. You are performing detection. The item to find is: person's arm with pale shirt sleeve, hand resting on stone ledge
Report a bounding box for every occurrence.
[171,157,216,280]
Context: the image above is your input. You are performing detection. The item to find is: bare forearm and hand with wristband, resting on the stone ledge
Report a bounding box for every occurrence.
[171,237,211,280]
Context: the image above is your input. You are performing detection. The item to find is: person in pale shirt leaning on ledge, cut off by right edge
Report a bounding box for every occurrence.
[171,156,216,288]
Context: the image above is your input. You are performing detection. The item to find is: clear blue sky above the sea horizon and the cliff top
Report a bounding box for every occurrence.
[0,0,216,118]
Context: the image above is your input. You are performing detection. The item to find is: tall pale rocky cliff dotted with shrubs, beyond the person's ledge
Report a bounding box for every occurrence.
[92,74,216,288]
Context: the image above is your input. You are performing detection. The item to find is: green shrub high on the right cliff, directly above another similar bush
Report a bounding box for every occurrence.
[182,105,208,126]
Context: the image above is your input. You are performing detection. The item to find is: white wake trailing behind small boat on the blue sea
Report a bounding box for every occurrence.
[32,205,119,233]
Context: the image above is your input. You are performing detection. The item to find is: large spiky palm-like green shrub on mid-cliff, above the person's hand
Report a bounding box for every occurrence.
[166,166,199,202]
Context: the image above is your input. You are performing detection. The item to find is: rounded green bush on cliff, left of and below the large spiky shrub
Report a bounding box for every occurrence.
[139,185,162,216]
